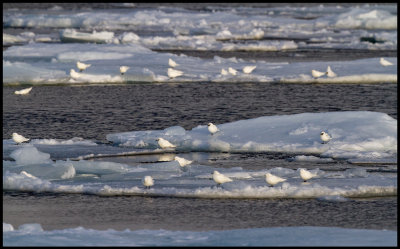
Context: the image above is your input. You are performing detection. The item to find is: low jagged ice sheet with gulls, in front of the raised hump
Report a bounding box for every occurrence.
[3,156,397,198]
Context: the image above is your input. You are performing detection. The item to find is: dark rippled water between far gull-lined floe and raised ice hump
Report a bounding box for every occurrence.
[3,83,397,142]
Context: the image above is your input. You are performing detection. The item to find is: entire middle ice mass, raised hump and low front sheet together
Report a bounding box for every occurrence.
[3,111,397,198]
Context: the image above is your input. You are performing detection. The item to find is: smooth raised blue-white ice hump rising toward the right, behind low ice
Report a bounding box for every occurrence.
[107,111,397,159]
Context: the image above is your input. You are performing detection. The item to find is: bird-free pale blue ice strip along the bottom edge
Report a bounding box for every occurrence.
[3,223,397,246]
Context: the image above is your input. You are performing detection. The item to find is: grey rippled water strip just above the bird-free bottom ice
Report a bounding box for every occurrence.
[3,192,397,231]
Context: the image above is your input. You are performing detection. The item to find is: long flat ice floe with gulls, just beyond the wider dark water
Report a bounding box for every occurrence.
[3,43,397,85]
